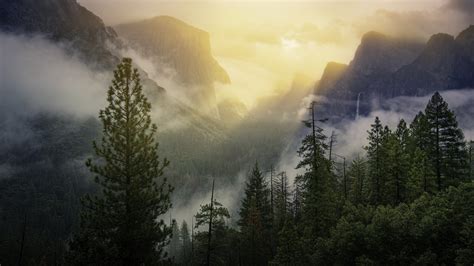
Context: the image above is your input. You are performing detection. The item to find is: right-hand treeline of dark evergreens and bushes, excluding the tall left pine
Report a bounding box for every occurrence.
[169,93,474,265]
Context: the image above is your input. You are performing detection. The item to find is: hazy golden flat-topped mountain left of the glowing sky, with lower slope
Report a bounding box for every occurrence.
[115,16,230,117]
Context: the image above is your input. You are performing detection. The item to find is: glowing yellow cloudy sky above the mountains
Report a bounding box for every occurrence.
[78,0,474,105]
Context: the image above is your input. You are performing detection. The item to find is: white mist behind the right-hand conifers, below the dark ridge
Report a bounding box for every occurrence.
[277,89,474,188]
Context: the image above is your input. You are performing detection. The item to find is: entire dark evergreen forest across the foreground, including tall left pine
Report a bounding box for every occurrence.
[0,59,474,265]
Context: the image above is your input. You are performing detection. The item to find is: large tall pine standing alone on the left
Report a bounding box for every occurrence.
[69,58,172,265]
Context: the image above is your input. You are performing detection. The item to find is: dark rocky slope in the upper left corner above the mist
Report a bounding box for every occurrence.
[0,0,121,69]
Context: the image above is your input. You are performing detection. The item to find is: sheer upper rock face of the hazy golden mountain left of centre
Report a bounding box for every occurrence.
[116,16,230,85]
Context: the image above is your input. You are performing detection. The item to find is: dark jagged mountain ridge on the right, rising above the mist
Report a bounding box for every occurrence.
[315,26,474,117]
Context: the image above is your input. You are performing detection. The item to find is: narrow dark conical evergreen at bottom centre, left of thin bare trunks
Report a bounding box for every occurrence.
[238,163,273,265]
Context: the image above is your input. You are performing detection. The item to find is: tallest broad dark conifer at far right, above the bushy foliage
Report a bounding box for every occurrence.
[425,92,468,191]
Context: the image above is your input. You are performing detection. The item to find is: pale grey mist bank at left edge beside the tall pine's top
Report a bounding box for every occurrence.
[0,34,109,116]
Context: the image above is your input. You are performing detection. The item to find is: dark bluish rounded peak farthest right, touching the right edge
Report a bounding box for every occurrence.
[370,30,474,97]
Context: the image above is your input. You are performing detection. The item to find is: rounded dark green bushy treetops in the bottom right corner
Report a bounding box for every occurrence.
[317,183,474,265]
